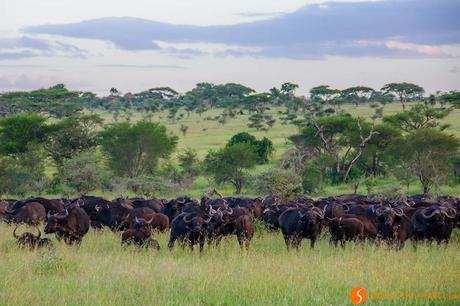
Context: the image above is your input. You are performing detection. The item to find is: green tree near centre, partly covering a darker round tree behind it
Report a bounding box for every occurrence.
[204,143,257,194]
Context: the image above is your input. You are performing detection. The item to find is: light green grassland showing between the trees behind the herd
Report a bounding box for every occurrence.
[90,103,460,197]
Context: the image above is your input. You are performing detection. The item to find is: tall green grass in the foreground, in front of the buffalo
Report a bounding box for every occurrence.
[0,224,460,305]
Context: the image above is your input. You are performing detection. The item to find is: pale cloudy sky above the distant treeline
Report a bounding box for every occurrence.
[0,0,460,95]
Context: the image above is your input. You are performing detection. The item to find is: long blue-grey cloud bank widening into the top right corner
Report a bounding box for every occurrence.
[25,0,460,59]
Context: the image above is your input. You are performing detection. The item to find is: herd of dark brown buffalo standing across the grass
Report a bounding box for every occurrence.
[0,195,460,251]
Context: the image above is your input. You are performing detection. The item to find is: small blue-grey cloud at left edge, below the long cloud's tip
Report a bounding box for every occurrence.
[0,36,85,60]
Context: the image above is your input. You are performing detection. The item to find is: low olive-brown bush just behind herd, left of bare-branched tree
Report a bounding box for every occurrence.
[253,169,302,202]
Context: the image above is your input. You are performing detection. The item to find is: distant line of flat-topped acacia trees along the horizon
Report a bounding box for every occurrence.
[0,82,460,125]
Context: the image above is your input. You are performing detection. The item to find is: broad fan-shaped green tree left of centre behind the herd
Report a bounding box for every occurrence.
[99,121,177,177]
